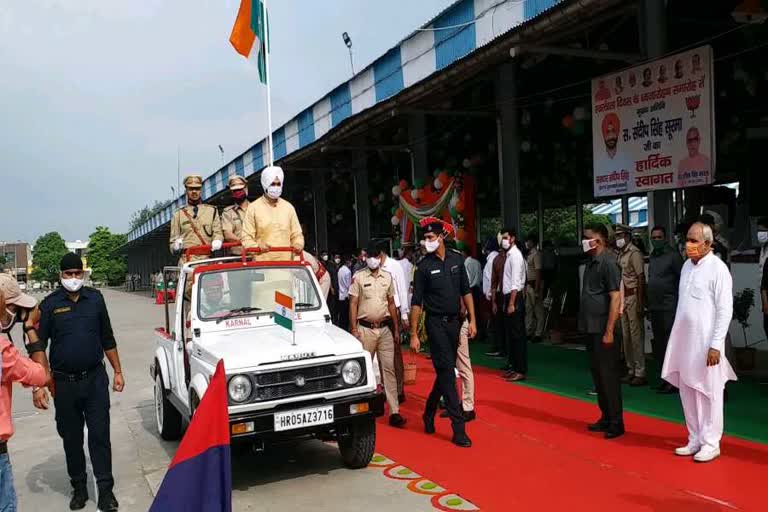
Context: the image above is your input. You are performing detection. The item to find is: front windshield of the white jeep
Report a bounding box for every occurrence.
[197,267,321,320]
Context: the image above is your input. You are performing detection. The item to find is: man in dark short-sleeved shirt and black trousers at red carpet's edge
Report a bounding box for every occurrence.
[579,224,624,439]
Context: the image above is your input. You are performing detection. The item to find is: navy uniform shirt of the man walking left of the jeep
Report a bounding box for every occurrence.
[37,287,117,373]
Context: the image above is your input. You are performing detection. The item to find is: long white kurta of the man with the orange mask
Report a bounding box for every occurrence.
[661,252,736,398]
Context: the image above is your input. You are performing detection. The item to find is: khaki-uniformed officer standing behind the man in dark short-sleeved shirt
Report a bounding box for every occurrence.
[616,224,648,386]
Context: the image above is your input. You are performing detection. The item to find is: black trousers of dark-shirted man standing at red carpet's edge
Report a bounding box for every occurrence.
[587,334,624,427]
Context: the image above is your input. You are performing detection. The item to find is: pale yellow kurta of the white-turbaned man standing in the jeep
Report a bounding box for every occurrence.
[242,196,304,261]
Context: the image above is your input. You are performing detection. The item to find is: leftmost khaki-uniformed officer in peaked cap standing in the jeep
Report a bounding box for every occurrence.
[170,175,224,266]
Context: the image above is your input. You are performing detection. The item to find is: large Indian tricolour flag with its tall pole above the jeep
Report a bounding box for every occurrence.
[229,0,275,166]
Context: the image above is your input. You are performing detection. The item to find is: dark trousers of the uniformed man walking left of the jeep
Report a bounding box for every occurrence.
[53,365,115,493]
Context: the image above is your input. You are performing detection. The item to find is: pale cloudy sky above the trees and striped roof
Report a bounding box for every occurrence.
[0,0,454,243]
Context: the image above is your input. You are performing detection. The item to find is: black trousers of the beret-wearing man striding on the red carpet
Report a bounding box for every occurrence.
[424,313,464,435]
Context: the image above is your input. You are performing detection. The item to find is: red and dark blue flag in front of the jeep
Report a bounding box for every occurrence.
[149,361,232,512]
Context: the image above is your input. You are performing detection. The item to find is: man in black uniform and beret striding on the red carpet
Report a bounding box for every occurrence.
[411,217,477,448]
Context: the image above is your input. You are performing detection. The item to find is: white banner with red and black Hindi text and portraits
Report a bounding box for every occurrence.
[592,46,715,197]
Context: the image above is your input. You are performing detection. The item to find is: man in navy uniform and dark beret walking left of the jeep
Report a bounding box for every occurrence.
[27,253,125,512]
